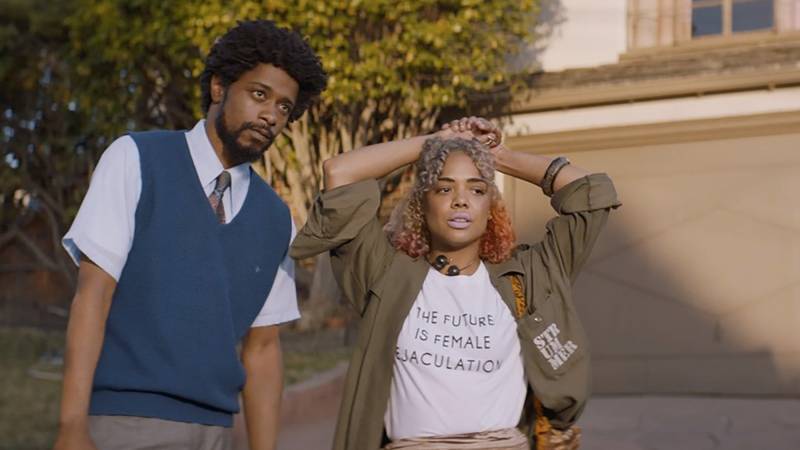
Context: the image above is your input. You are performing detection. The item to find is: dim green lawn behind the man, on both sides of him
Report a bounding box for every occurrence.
[0,328,350,450]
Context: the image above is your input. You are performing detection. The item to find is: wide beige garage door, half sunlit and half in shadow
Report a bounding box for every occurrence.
[507,134,800,394]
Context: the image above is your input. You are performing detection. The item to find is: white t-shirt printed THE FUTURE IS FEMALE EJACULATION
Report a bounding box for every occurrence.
[384,263,527,440]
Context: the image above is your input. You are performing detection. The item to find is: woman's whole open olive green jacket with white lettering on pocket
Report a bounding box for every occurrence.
[291,174,620,450]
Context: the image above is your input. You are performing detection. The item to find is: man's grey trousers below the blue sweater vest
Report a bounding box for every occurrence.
[89,416,233,450]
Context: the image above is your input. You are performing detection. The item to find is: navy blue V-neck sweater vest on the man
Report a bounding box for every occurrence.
[90,131,291,426]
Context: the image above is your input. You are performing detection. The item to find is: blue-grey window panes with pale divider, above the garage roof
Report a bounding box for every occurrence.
[691,0,776,38]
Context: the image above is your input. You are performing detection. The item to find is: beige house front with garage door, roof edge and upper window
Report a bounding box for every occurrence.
[503,0,800,395]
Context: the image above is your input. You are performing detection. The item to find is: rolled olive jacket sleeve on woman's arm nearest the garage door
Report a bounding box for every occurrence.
[520,173,621,284]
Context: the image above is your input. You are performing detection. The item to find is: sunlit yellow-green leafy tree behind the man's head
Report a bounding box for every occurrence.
[70,0,537,223]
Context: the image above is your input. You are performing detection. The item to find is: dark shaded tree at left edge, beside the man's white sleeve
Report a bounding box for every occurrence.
[0,0,88,286]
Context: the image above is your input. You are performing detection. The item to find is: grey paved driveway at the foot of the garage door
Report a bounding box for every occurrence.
[278,396,800,450]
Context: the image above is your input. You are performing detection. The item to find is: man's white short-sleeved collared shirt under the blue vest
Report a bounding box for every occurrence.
[62,120,300,327]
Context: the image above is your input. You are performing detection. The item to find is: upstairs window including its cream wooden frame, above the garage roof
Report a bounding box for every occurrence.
[628,0,800,49]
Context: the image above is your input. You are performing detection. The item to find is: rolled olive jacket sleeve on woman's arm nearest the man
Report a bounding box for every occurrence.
[290,180,395,314]
